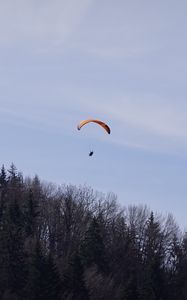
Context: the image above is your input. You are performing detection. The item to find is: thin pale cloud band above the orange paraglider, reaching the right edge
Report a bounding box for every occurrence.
[62,88,187,140]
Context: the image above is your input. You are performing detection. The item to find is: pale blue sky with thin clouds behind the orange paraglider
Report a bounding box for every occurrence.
[0,0,187,228]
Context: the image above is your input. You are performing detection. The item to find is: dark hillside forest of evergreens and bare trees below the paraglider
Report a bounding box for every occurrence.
[0,164,187,300]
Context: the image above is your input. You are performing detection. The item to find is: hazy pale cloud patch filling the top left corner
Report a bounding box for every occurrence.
[0,0,92,48]
